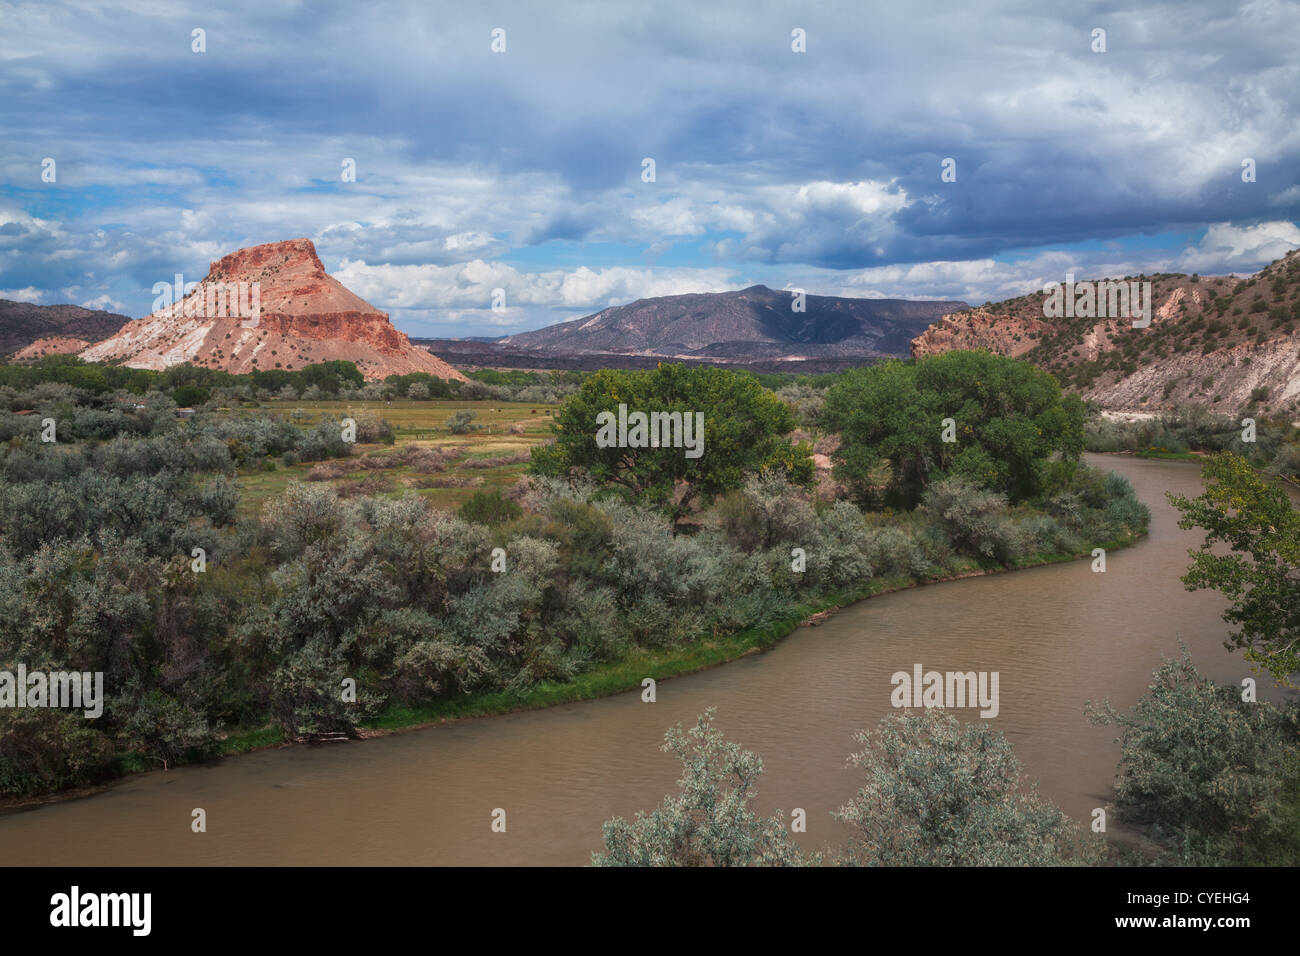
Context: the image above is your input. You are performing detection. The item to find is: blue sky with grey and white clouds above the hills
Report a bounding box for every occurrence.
[0,0,1300,336]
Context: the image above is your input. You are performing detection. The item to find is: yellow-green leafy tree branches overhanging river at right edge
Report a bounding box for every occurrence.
[1167,451,1300,685]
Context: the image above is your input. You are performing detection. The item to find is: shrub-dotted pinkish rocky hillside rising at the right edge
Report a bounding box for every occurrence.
[911,250,1300,414]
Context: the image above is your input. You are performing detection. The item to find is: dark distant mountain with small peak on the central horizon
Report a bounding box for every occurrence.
[498,285,967,362]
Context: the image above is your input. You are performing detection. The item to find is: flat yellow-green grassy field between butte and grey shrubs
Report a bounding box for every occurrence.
[221,399,559,516]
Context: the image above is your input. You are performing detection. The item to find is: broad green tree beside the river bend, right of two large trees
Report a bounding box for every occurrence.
[822,351,1086,509]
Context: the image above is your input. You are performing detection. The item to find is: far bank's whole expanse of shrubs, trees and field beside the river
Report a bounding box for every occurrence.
[0,352,1148,800]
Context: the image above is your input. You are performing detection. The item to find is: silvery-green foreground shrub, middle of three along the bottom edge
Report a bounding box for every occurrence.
[835,710,1093,866]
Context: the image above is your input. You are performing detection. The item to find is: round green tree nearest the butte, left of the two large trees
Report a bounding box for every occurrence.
[532,364,813,518]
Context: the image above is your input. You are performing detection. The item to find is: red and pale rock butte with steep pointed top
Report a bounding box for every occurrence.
[81,239,467,381]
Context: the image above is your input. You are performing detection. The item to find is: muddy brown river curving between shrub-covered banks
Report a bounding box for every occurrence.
[0,457,1283,865]
